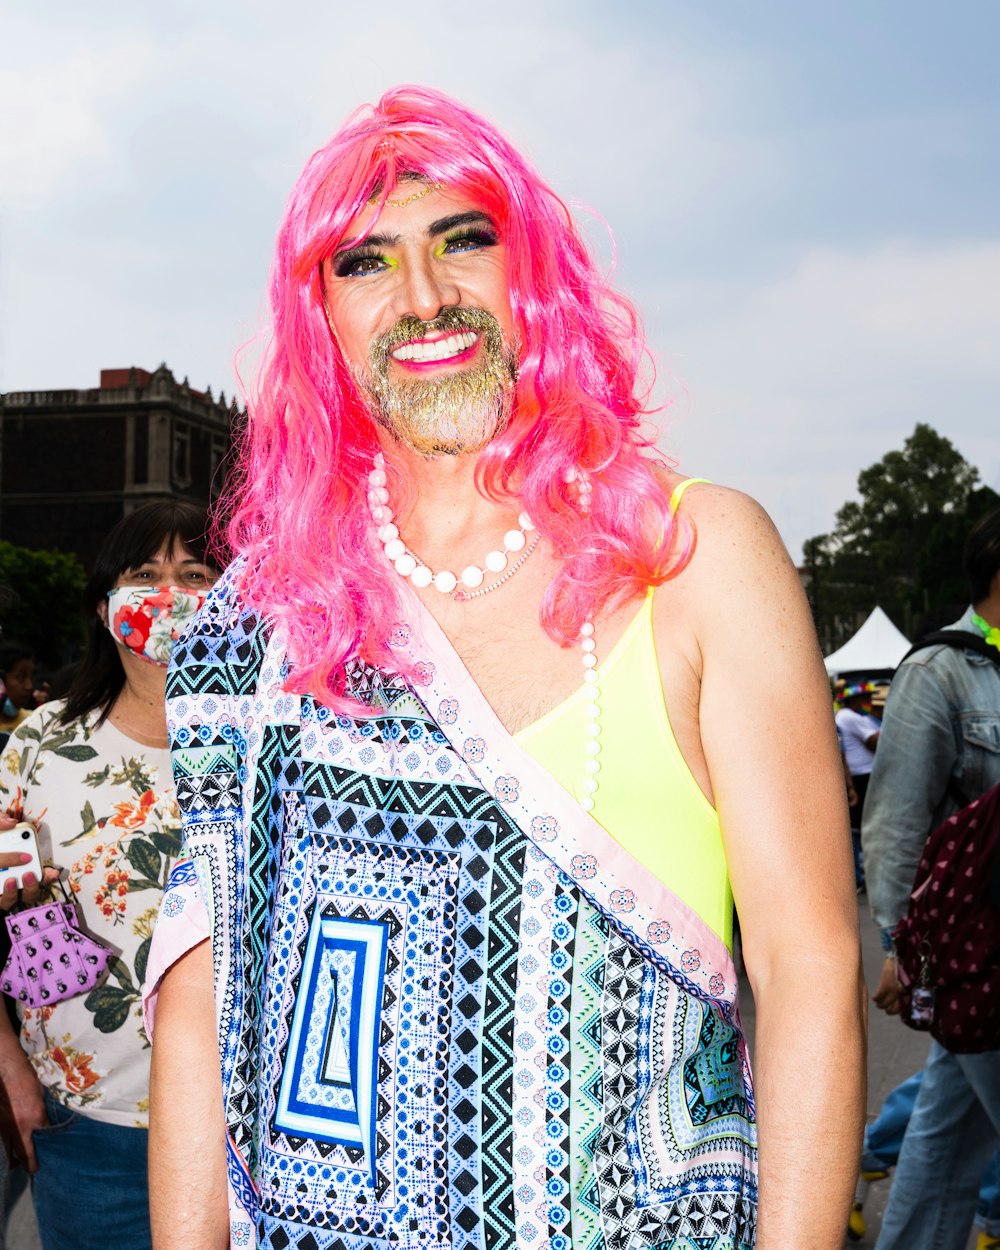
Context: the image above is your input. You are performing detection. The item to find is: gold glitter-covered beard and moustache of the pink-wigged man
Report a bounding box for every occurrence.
[358,309,518,456]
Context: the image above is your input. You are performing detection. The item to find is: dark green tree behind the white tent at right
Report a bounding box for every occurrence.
[803,424,1000,651]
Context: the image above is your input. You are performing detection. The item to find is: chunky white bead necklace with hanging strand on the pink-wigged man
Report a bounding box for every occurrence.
[368,453,601,811]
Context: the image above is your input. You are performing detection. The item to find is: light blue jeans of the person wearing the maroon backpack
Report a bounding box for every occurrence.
[875,1041,1000,1250]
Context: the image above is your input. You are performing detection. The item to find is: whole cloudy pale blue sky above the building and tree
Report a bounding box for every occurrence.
[0,0,1000,559]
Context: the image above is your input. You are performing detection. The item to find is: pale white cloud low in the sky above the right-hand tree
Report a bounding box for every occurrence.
[654,240,1000,553]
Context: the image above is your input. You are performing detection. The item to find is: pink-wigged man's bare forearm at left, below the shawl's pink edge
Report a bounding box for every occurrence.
[149,941,229,1250]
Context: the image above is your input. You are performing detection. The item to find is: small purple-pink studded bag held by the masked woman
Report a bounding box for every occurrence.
[0,899,114,1008]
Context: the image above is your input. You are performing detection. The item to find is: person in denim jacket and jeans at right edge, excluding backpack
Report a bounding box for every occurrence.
[863,509,1000,1250]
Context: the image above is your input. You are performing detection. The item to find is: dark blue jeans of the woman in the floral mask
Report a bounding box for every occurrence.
[31,1094,153,1250]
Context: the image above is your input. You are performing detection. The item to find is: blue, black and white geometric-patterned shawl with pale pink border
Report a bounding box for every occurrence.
[148,570,756,1250]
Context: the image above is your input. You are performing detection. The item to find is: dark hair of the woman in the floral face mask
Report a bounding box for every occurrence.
[59,503,211,725]
